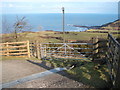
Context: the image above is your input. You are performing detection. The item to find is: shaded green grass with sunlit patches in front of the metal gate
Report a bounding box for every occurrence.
[42,58,111,88]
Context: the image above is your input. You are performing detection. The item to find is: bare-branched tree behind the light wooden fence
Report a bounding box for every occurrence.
[13,16,32,41]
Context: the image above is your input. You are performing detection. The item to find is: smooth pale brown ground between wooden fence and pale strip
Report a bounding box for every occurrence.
[0,60,46,83]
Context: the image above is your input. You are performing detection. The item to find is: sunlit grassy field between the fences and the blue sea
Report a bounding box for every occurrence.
[1,31,120,43]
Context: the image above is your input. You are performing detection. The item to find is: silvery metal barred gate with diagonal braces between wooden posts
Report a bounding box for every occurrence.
[40,43,93,60]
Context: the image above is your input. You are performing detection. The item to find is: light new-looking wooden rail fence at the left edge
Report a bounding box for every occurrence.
[0,41,30,57]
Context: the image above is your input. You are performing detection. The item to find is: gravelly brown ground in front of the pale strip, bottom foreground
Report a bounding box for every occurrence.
[12,72,85,88]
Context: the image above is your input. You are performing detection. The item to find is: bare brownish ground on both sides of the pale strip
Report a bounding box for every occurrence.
[0,60,86,88]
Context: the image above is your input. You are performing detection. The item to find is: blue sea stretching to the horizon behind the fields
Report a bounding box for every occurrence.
[2,13,118,33]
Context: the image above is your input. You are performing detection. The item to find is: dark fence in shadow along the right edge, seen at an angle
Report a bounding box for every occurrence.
[107,34,120,87]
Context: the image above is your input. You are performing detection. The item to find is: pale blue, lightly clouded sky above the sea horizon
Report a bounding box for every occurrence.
[0,0,119,14]
